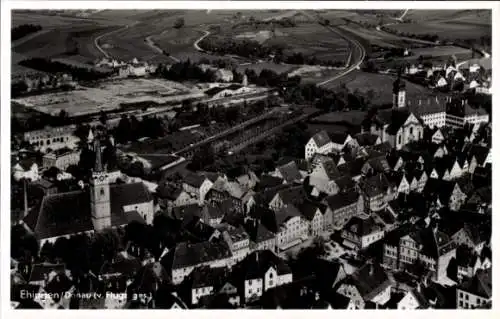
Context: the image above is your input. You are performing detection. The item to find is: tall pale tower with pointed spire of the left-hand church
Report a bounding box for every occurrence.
[90,138,111,231]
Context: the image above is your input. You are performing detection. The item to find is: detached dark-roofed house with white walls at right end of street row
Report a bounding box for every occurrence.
[342,216,385,249]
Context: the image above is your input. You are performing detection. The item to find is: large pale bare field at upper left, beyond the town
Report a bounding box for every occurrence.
[14,79,203,116]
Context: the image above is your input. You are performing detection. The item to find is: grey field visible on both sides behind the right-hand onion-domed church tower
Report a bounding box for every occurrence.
[325,71,430,104]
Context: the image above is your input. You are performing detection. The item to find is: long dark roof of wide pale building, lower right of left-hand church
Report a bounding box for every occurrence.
[172,241,232,269]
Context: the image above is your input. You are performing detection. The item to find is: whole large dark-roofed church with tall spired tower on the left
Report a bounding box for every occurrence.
[23,131,154,246]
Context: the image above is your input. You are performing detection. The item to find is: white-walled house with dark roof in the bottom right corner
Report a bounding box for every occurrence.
[457,268,492,309]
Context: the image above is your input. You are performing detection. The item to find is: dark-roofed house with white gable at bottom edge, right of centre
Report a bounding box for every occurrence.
[337,262,393,309]
